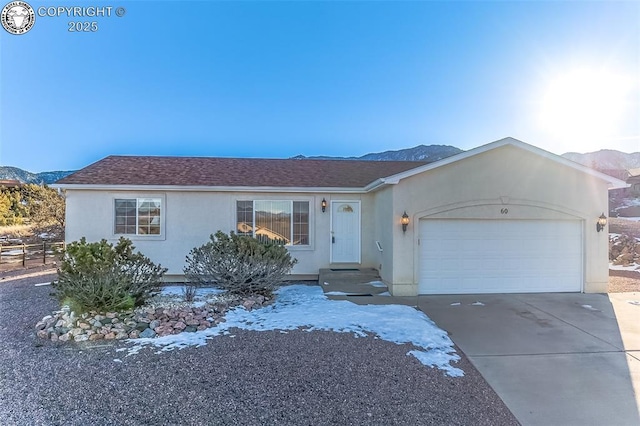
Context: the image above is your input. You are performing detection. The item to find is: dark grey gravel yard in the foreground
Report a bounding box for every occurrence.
[0,273,518,425]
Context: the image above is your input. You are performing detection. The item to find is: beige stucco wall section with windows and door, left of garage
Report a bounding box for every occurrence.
[66,189,379,279]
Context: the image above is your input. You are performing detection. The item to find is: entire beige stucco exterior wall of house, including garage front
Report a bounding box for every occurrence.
[66,145,608,295]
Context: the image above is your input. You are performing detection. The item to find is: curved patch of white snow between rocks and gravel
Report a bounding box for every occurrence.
[119,285,464,377]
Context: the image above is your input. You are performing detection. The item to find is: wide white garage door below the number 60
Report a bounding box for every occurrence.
[419,219,582,294]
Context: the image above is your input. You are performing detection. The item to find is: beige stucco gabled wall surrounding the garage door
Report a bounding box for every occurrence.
[378,145,608,295]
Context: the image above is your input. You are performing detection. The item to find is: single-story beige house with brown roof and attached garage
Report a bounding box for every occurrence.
[56,138,626,296]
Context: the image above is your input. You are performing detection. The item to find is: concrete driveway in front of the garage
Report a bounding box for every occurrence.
[418,293,640,425]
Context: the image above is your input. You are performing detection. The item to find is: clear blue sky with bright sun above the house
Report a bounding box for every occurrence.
[0,1,640,172]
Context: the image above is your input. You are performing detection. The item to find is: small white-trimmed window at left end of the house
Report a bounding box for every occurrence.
[114,198,162,235]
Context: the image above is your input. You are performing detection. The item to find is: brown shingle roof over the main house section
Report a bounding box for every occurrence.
[56,156,426,188]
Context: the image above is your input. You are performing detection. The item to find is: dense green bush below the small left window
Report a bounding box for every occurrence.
[52,237,167,312]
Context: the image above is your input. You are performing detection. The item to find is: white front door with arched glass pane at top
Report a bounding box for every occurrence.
[331,201,360,263]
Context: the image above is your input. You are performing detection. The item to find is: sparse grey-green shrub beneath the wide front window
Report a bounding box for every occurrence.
[184,231,297,296]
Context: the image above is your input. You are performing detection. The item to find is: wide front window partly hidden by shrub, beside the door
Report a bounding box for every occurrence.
[236,200,309,246]
